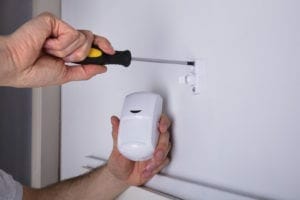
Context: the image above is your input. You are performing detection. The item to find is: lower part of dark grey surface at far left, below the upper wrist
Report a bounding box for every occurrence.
[0,87,31,185]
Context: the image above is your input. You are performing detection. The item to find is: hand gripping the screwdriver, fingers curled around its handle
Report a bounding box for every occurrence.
[0,13,114,87]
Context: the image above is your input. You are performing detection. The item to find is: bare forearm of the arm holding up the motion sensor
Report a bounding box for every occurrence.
[23,166,128,200]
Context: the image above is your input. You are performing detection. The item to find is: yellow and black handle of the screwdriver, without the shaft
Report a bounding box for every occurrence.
[76,45,131,67]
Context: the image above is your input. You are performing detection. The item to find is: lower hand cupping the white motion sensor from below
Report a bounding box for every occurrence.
[107,115,171,185]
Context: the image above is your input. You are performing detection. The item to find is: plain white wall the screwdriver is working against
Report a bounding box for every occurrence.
[61,0,300,199]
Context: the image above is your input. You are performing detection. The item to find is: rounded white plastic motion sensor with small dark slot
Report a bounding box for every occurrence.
[118,92,163,161]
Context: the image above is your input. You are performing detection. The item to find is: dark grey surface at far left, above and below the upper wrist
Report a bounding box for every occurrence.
[0,0,32,185]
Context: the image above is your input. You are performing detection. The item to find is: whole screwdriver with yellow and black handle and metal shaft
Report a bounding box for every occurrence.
[76,46,195,67]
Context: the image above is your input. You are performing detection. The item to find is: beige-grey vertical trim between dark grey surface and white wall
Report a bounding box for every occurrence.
[31,0,61,188]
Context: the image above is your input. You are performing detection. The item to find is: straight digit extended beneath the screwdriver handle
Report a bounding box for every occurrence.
[62,65,107,83]
